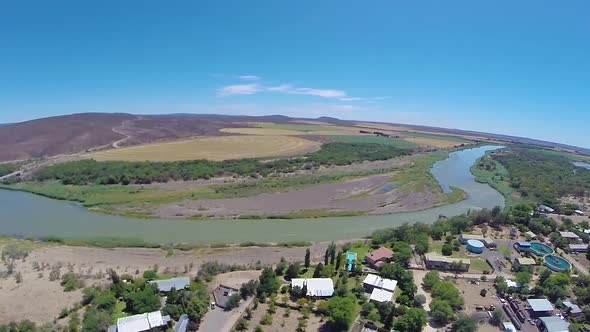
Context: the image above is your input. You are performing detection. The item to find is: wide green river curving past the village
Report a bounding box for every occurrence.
[0,146,504,244]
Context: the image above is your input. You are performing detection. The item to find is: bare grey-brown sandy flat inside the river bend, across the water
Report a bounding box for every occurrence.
[155,174,437,218]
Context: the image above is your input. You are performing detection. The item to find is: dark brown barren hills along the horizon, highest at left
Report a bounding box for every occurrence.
[0,113,590,162]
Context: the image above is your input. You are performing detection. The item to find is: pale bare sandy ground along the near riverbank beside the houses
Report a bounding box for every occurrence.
[0,242,336,324]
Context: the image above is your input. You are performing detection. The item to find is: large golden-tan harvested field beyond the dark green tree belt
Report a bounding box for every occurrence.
[87,136,320,161]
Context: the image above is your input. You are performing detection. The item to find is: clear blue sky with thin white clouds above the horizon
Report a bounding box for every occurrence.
[0,0,590,147]
